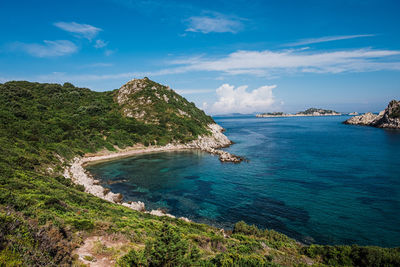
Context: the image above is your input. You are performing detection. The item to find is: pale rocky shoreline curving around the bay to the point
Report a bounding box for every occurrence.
[64,124,245,222]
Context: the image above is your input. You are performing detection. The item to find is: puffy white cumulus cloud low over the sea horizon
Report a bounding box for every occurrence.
[203,83,276,114]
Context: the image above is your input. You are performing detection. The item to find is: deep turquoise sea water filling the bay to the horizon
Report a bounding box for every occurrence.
[88,116,400,247]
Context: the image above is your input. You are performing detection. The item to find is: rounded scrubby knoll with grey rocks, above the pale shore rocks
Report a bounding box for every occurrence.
[114,78,215,140]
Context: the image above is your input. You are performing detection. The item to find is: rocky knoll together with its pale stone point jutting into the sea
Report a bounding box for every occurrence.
[114,78,243,163]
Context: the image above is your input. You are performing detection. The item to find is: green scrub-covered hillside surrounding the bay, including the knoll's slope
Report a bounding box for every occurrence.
[0,79,400,266]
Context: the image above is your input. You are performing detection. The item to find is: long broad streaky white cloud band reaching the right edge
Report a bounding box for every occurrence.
[170,49,400,76]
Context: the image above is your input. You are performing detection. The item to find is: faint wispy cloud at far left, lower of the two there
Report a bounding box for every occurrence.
[11,40,78,57]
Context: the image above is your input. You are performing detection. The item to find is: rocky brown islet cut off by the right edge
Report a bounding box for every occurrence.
[343,100,400,129]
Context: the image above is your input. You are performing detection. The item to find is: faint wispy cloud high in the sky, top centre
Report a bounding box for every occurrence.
[186,15,243,33]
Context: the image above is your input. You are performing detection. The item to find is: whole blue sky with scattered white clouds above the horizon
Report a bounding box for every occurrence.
[0,0,400,114]
